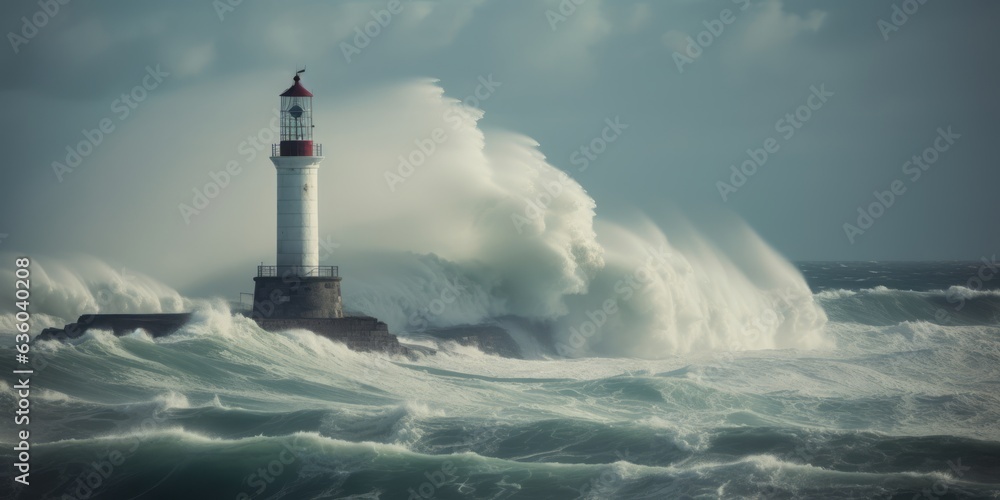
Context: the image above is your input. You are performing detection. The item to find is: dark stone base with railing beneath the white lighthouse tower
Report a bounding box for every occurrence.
[253,276,344,319]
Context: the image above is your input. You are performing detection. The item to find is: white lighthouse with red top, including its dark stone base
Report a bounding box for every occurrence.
[254,70,343,319]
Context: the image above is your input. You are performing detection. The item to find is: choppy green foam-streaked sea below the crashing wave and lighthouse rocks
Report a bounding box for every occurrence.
[0,261,1000,500]
